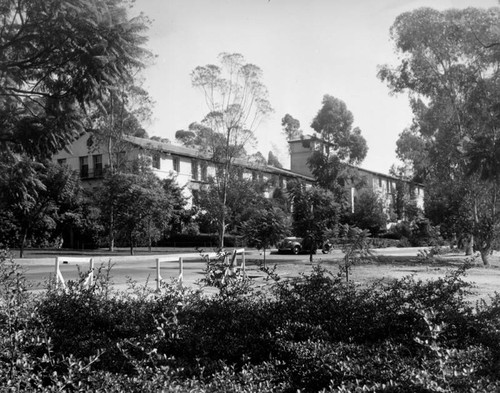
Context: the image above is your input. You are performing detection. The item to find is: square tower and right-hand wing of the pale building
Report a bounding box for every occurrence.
[288,135,424,211]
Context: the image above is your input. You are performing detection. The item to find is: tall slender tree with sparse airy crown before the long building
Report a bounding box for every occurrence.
[191,53,272,247]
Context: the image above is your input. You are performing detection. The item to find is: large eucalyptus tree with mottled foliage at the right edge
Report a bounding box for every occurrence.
[379,8,500,264]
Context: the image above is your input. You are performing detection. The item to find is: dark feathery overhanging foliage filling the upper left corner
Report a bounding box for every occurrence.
[0,0,148,158]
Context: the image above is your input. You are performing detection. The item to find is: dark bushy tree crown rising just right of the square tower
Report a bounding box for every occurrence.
[308,95,368,194]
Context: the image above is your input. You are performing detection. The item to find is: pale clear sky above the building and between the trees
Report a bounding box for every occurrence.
[134,0,498,173]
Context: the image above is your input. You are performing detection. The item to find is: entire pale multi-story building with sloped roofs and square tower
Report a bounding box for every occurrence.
[54,134,424,216]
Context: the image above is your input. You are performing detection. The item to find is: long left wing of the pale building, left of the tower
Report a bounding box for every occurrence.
[54,134,314,201]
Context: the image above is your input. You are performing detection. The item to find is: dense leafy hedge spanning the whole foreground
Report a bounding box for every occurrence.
[0,250,500,392]
